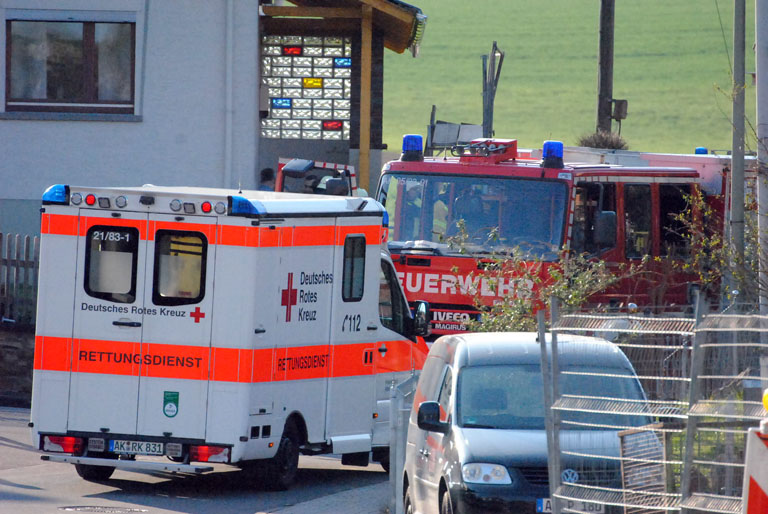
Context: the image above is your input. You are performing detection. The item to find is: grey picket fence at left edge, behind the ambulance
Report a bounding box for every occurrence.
[0,233,40,327]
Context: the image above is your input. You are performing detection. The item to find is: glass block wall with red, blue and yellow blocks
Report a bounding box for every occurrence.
[261,36,352,140]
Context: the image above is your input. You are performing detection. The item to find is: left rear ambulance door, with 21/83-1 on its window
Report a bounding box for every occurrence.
[67,209,147,434]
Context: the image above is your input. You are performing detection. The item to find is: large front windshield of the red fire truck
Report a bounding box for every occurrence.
[378,173,568,260]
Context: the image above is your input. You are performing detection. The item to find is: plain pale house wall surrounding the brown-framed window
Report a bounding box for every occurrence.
[0,0,258,232]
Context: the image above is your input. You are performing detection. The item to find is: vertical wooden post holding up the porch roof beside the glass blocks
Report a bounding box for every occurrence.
[357,5,373,191]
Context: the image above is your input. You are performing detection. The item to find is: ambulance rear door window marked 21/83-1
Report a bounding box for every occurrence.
[85,225,139,303]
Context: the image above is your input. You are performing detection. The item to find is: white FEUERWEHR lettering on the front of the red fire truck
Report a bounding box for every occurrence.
[397,271,533,297]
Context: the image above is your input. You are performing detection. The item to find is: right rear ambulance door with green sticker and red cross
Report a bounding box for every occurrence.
[137,214,216,439]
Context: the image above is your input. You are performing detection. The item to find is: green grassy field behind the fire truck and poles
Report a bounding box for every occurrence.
[384,0,755,153]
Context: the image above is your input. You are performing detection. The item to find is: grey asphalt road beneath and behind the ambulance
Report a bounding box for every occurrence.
[0,407,389,514]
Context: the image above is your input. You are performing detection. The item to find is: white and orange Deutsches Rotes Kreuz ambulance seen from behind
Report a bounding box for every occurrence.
[30,185,429,489]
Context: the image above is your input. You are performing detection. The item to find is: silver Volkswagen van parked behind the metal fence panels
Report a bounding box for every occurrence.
[403,333,651,514]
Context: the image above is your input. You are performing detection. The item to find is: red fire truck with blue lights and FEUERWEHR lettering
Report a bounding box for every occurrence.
[376,135,723,335]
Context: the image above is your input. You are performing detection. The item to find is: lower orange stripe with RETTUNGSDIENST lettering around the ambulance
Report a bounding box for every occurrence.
[34,336,423,383]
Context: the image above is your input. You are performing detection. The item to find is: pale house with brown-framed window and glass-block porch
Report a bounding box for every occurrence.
[0,0,426,233]
